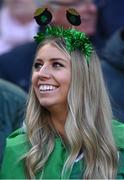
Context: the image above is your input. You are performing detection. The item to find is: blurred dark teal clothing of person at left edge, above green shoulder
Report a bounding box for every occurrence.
[0,79,26,165]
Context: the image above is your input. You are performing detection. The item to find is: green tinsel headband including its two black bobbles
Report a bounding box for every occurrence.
[34,8,93,64]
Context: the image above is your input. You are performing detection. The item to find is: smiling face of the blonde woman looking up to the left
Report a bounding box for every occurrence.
[32,44,71,110]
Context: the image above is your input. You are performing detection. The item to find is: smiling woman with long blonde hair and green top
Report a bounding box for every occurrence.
[1,26,124,179]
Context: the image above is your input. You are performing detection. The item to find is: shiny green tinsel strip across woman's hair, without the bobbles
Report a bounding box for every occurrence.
[34,26,93,64]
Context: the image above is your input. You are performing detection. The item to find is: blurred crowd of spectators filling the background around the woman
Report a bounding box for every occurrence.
[0,0,124,168]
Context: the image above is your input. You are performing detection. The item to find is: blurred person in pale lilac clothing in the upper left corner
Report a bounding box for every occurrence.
[0,0,37,54]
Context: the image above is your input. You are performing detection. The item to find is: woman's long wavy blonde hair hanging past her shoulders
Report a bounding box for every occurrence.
[25,38,117,179]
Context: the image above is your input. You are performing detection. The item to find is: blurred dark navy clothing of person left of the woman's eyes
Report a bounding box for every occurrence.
[0,42,37,92]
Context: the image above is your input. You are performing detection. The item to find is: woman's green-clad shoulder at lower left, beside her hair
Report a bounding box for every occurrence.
[0,129,29,179]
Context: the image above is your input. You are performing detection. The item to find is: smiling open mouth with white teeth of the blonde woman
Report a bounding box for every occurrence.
[39,84,58,93]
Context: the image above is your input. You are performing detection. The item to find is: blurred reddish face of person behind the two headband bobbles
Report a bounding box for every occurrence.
[49,0,97,37]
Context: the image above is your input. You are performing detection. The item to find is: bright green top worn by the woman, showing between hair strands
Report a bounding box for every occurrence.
[0,121,124,179]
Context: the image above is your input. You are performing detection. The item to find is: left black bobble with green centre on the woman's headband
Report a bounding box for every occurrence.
[34,8,52,27]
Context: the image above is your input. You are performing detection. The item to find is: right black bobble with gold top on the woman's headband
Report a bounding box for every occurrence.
[66,8,81,26]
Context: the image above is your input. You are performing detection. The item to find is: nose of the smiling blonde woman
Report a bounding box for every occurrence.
[38,65,51,78]
